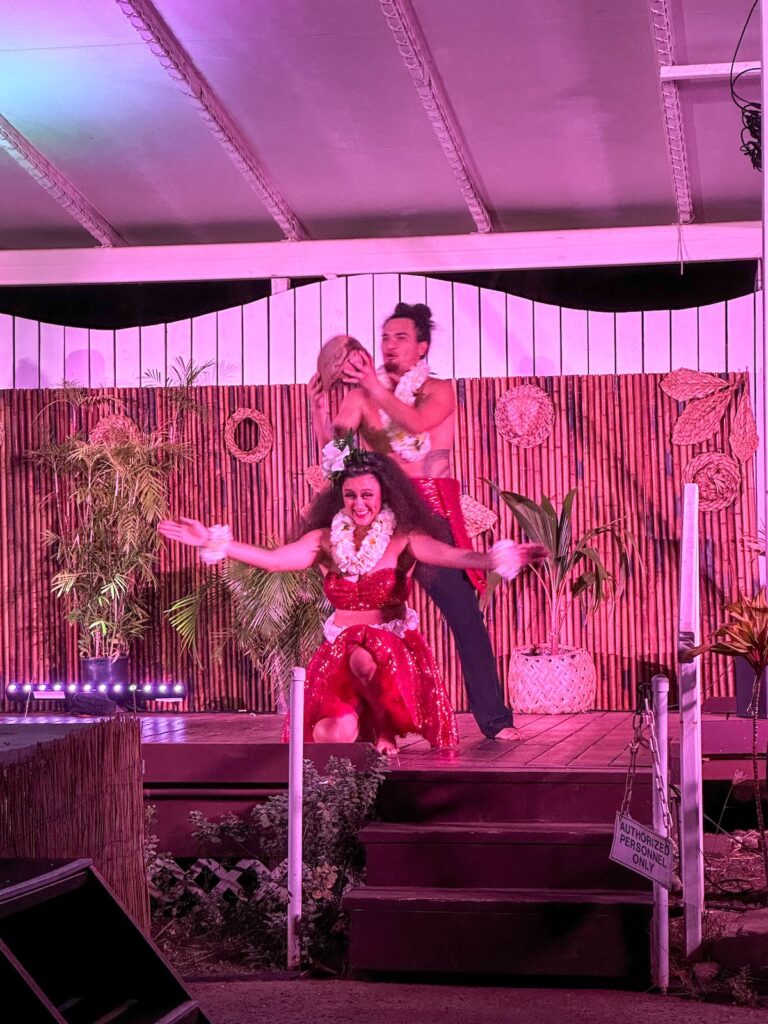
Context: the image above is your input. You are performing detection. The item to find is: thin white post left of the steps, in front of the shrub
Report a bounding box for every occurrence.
[288,668,306,970]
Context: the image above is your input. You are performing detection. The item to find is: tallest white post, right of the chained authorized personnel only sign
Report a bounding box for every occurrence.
[678,483,703,956]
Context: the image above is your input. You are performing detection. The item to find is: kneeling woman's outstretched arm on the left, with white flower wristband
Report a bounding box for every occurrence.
[158,518,323,572]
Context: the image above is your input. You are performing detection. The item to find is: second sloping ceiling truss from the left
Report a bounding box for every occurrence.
[116,0,308,242]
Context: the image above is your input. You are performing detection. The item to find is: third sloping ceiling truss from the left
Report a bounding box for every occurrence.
[379,0,494,232]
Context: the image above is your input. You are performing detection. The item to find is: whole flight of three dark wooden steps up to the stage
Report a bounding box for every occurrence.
[352,765,652,987]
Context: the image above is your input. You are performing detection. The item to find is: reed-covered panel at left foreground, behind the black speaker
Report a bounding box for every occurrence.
[0,715,150,932]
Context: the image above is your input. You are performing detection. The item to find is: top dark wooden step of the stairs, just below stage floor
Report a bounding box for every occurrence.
[378,768,651,824]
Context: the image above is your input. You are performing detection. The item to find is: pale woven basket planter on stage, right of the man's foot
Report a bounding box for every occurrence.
[509,647,597,715]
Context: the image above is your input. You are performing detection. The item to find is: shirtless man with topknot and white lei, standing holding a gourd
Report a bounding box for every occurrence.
[309,302,518,739]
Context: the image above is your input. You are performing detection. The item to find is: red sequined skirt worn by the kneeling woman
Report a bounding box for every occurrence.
[290,626,459,748]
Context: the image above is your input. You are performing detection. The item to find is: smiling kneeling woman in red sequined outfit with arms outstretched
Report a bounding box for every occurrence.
[158,441,546,754]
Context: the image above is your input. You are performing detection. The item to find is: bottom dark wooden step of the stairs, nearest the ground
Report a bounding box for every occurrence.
[344,887,652,987]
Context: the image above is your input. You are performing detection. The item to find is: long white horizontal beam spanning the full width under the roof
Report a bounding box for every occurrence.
[0,221,762,285]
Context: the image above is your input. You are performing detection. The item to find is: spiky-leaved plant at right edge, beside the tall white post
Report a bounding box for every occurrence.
[682,587,768,890]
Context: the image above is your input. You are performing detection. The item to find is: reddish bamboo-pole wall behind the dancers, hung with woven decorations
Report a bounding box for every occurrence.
[0,374,757,711]
